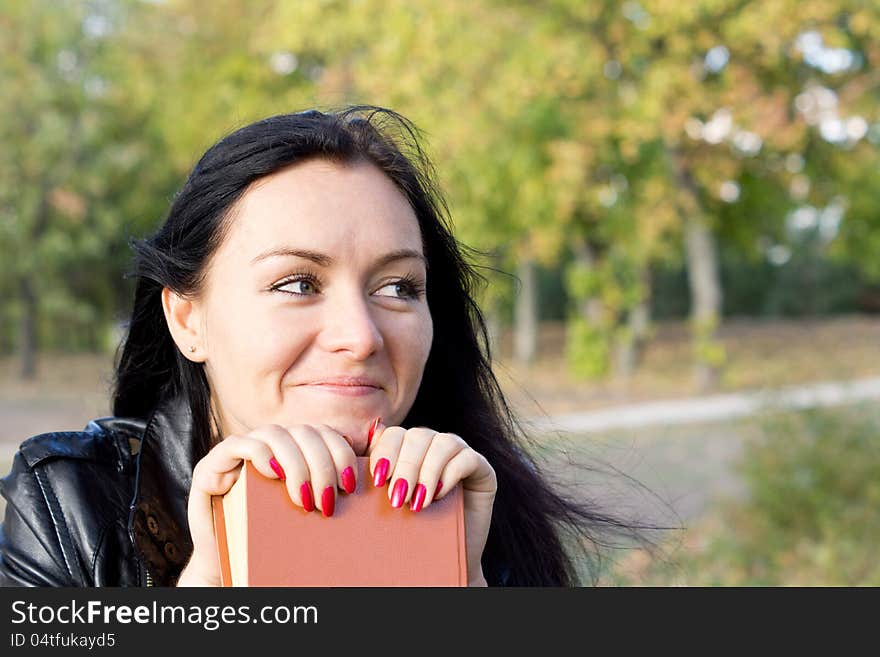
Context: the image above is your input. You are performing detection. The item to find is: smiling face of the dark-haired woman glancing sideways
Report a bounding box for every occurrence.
[166,159,433,453]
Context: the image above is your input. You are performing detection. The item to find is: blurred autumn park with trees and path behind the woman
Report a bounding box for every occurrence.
[0,0,880,585]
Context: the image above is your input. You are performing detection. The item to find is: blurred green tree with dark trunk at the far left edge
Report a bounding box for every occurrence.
[0,1,138,378]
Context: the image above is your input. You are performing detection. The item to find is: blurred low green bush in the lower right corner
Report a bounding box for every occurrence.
[624,407,880,586]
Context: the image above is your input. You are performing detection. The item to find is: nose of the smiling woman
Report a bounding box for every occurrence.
[319,294,385,360]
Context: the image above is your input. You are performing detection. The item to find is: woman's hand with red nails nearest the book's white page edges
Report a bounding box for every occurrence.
[177,424,357,586]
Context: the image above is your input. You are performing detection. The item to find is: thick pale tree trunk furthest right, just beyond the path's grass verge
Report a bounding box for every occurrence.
[685,217,721,390]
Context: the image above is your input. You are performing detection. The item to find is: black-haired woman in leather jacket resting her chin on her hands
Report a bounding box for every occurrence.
[0,107,640,586]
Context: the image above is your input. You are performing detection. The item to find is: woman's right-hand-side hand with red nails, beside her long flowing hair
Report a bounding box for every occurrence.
[367,423,498,586]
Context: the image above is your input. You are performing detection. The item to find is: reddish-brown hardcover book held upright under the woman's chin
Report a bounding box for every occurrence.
[213,457,467,586]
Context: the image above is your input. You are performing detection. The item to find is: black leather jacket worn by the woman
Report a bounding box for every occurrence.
[0,399,196,586]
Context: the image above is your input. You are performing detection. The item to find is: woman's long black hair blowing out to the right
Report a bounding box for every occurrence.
[113,105,652,586]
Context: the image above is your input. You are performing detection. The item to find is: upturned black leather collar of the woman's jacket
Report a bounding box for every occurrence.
[128,397,198,586]
